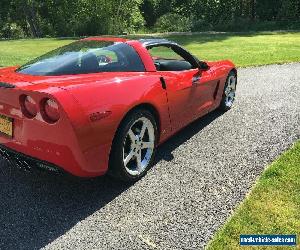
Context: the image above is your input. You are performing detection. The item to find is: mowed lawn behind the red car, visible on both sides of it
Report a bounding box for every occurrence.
[0,32,300,67]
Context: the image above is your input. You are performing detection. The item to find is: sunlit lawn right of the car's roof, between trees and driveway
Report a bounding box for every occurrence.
[166,32,300,67]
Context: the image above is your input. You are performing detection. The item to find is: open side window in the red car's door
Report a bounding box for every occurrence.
[148,46,192,71]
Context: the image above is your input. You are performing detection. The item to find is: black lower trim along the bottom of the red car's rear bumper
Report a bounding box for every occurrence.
[0,145,65,173]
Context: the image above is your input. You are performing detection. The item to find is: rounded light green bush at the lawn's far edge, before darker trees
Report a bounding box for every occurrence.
[155,13,192,32]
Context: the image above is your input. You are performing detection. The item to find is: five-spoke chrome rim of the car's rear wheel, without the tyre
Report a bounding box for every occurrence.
[123,117,155,176]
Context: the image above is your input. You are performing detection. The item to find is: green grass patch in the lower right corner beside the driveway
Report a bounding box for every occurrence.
[207,141,300,250]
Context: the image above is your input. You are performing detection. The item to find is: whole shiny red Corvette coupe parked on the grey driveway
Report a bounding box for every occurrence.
[0,37,237,181]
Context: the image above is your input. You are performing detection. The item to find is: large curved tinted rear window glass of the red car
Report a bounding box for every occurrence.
[17,40,145,76]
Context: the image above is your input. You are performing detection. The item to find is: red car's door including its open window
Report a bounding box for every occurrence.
[148,45,215,131]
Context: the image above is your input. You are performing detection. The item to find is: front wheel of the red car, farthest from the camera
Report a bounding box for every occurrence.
[220,71,237,111]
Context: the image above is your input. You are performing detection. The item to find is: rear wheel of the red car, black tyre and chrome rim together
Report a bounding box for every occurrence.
[109,109,157,181]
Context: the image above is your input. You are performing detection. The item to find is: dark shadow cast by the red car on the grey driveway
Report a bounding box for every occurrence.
[0,111,222,249]
